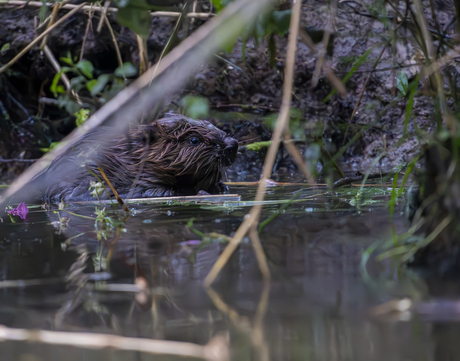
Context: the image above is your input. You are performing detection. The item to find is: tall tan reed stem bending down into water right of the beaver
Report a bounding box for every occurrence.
[204,0,302,287]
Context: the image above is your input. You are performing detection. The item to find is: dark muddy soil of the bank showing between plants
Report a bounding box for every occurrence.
[0,0,460,182]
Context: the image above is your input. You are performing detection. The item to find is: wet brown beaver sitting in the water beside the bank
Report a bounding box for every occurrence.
[45,115,238,201]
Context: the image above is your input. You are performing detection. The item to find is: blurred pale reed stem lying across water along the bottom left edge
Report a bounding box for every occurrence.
[0,325,229,361]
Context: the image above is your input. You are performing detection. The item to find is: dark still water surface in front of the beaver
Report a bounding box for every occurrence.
[0,187,460,361]
